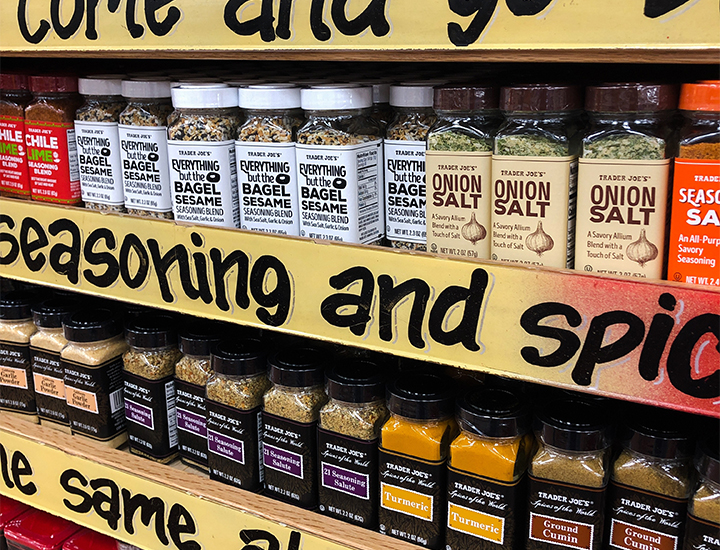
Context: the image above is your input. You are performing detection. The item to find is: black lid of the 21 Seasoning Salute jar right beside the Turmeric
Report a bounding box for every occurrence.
[326,359,385,403]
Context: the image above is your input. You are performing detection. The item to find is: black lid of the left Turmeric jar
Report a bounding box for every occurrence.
[387,374,453,420]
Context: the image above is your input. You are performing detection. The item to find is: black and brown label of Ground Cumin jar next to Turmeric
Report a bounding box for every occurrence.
[527,476,606,550]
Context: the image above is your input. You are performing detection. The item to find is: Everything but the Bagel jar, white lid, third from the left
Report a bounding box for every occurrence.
[168,83,240,227]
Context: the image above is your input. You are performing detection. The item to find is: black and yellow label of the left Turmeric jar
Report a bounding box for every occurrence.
[378,447,446,549]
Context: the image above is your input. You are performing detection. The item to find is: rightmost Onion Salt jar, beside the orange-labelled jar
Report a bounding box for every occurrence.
[575,83,677,279]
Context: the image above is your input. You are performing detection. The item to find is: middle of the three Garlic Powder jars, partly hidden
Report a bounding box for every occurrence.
[30,298,77,433]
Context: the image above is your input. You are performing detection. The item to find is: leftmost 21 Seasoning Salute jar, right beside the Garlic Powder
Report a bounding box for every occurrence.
[123,315,181,464]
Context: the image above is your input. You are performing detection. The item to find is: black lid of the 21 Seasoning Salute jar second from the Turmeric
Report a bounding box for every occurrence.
[268,347,325,388]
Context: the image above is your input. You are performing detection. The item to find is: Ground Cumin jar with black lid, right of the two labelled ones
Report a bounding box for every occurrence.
[608,409,693,549]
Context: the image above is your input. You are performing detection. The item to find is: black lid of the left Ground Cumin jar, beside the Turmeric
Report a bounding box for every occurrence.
[538,399,609,451]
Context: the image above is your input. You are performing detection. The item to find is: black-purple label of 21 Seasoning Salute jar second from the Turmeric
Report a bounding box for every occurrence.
[262,412,318,508]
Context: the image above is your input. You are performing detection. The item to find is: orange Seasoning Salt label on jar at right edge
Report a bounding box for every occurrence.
[667,158,720,286]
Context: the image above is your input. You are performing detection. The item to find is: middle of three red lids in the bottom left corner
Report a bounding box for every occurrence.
[5,510,80,550]
